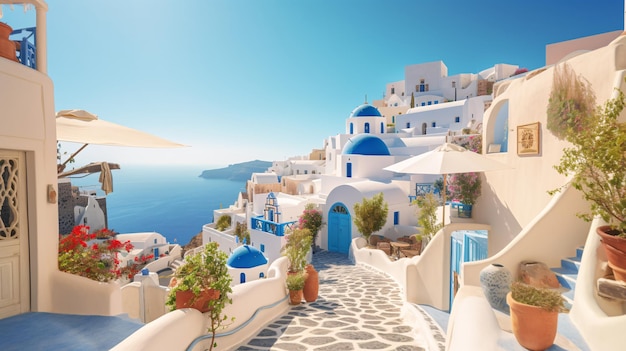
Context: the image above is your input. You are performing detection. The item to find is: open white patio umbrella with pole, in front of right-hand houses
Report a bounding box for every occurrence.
[383,143,509,223]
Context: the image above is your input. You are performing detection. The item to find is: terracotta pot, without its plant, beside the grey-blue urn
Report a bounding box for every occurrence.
[506,292,559,351]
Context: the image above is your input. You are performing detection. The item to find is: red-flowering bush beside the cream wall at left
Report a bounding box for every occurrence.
[59,225,154,282]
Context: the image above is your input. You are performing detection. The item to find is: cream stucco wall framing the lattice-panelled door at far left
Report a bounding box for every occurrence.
[0,58,59,311]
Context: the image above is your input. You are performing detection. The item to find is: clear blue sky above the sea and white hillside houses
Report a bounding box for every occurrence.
[0,0,624,169]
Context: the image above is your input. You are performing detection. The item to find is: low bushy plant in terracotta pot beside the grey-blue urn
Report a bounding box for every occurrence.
[506,281,568,350]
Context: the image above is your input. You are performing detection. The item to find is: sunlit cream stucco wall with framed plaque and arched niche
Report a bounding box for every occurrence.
[474,37,626,252]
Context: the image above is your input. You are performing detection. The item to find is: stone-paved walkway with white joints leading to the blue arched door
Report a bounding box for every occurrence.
[238,251,426,351]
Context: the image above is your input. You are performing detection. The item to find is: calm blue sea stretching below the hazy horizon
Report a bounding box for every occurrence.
[71,165,245,246]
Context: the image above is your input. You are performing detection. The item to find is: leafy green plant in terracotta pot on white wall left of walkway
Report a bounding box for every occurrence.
[166,242,233,349]
